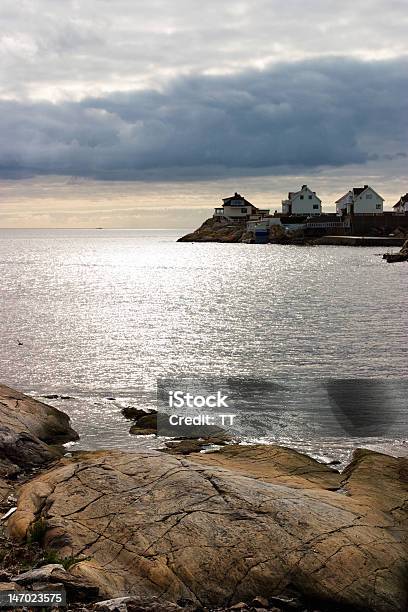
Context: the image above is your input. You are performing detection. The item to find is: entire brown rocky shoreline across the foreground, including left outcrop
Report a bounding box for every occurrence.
[0,386,408,612]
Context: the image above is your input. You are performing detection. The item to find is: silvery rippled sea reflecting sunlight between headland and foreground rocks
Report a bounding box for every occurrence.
[0,229,408,465]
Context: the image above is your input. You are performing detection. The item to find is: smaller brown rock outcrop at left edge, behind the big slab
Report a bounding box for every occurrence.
[0,385,78,500]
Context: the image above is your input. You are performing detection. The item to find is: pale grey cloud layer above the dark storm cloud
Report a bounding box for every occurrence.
[0,0,408,100]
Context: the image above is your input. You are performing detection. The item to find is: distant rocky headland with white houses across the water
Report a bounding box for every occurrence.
[179,185,408,246]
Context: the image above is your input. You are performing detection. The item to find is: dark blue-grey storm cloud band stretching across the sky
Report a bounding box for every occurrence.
[0,58,408,180]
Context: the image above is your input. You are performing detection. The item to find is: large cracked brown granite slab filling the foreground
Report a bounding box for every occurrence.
[8,447,408,612]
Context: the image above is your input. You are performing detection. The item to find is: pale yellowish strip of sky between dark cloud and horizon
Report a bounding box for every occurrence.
[0,164,405,230]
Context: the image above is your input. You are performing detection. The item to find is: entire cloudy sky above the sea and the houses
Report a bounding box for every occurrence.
[0,0,408,228]
